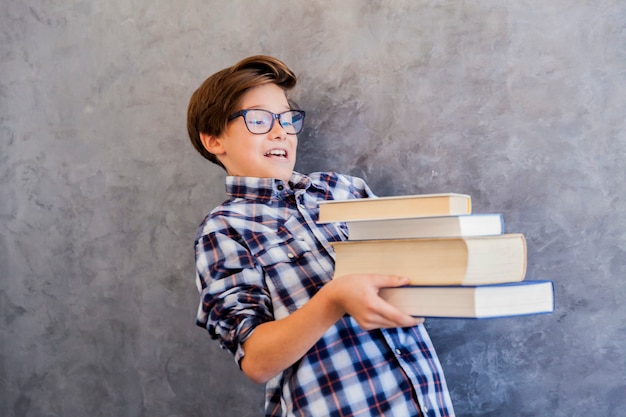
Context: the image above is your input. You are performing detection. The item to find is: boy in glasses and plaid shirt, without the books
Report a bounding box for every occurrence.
[187,56,454,417]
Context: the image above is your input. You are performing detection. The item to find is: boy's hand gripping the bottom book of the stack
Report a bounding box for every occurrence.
[323,274,424,330]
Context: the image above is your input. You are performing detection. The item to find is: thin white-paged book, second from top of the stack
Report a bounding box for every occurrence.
[346,213,504,240]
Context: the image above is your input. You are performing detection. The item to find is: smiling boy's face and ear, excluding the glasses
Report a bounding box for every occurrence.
[203,84,298,181]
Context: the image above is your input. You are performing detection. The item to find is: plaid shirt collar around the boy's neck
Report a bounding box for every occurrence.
[226,171,312,200]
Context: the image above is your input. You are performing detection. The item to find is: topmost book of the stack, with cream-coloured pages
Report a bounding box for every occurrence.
[318,193,472,223]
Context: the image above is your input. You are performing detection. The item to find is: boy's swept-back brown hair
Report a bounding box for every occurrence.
[187,55,296,168]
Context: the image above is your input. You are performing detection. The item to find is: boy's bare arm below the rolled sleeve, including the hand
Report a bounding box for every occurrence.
[241,275,423,382]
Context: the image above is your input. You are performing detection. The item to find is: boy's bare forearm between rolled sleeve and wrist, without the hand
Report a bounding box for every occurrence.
[241,286,345,383]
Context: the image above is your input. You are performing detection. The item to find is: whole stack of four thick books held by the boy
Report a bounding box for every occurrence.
[318,193,554,318]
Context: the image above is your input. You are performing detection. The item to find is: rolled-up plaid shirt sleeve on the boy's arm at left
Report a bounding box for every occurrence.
[195,221,273,363]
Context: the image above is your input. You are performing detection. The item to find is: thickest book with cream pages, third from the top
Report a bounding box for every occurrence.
[332,233,526,285]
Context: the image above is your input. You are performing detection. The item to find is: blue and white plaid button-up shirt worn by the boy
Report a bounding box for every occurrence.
[195,172,454,417]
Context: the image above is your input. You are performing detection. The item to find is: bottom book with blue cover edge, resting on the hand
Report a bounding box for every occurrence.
[380,281,554,319]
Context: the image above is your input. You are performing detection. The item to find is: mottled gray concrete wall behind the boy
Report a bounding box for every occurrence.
[0,0,626,417]
